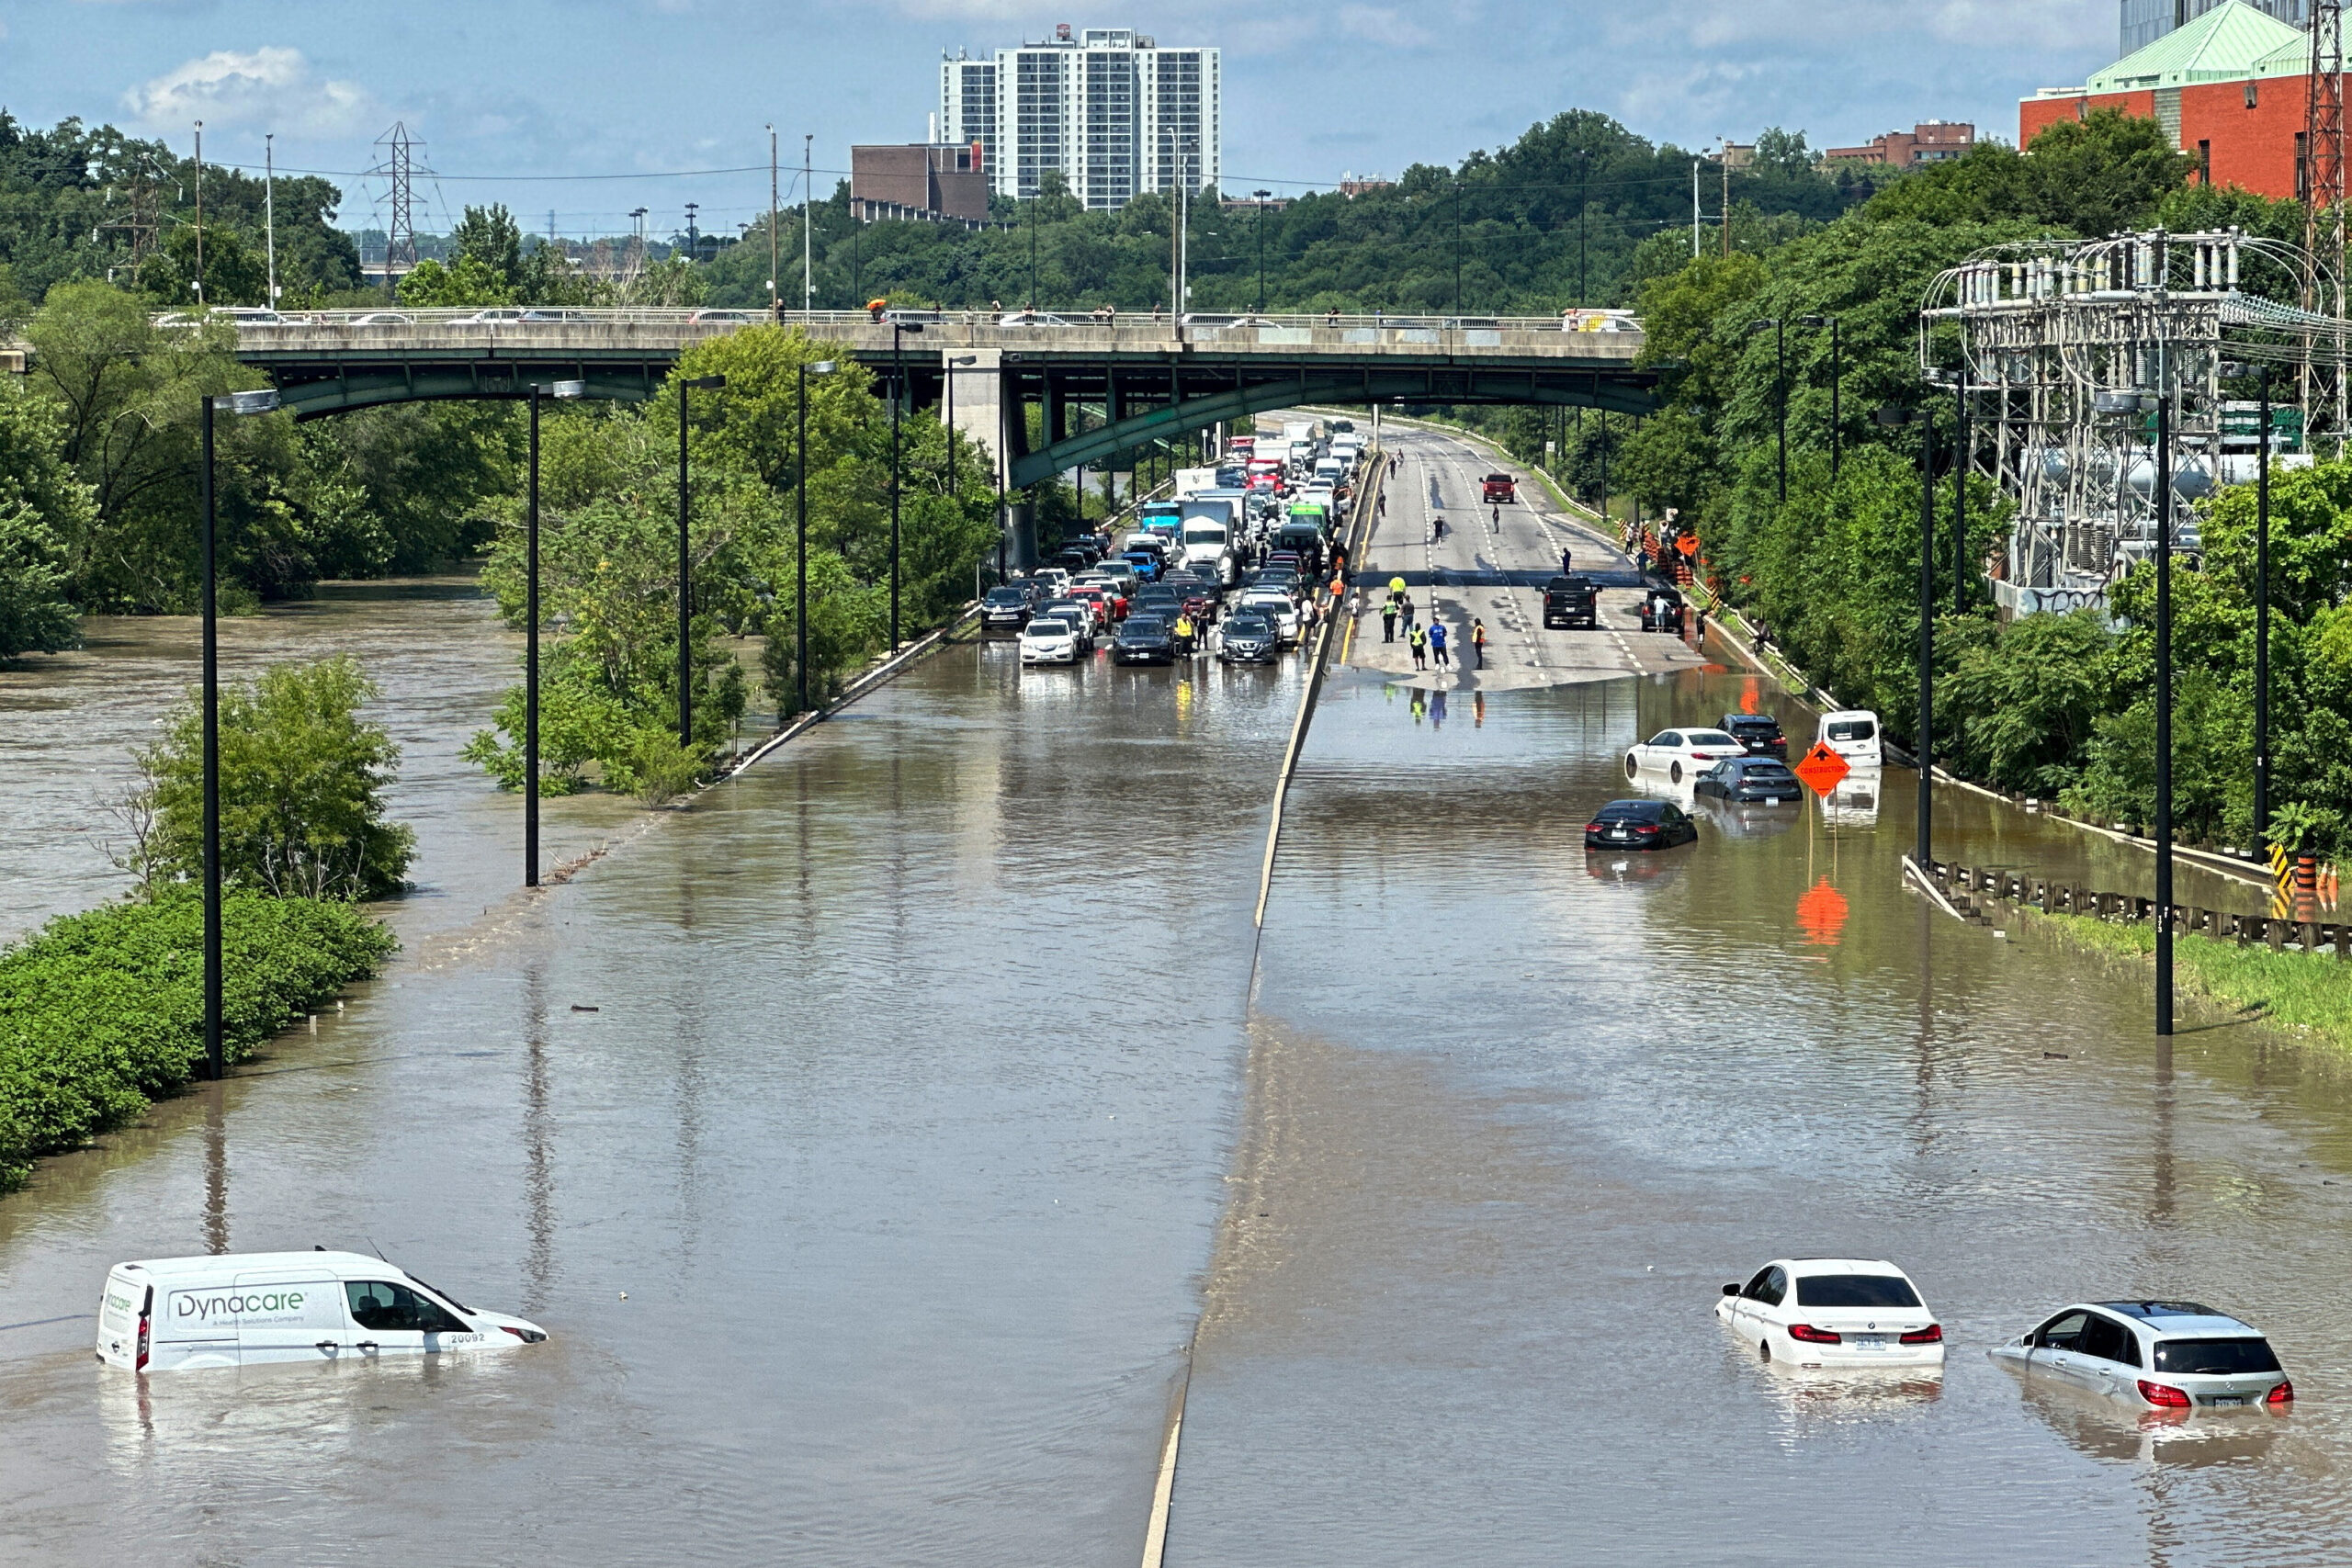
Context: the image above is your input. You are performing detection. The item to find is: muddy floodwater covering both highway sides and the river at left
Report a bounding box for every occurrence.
[0,434,2352,1565]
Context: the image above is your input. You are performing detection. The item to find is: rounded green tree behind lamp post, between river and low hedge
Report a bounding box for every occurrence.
[127,656,416,898]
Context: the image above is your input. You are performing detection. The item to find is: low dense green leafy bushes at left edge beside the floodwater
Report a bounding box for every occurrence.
[0,888,398,1192]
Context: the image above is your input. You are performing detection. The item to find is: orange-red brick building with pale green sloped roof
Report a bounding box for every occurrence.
[2018,0,2312,197]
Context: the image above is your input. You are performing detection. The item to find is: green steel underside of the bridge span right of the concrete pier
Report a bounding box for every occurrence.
[1002,355,1658,489]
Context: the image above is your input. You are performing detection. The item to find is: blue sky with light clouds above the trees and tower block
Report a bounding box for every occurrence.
[0,0,2117,235]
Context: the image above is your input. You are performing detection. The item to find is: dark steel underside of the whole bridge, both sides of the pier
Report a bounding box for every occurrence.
[244,348,1656,489]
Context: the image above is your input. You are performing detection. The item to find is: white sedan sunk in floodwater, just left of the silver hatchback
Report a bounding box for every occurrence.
[1714,1258,1943,1368]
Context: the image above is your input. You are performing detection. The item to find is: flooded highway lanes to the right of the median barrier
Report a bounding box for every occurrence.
[1169,432,2352,1563]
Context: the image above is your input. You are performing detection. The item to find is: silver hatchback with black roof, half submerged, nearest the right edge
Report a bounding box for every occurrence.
[1985,1300,2296,1416]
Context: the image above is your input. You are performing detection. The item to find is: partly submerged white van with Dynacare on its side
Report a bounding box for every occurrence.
[99,1251,548,1373]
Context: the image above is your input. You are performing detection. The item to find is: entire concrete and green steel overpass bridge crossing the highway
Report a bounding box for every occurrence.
[220,308,1656,489]
